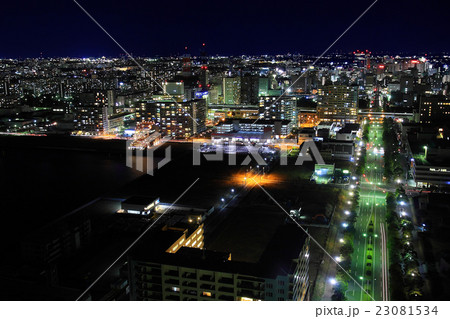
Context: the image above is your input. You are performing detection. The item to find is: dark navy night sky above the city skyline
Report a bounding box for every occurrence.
[0,0,450,58]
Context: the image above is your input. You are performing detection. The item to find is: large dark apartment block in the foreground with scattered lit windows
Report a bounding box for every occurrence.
[128,225,310,301]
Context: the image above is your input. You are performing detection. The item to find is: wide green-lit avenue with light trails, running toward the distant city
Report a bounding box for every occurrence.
[346,123,388,301]
